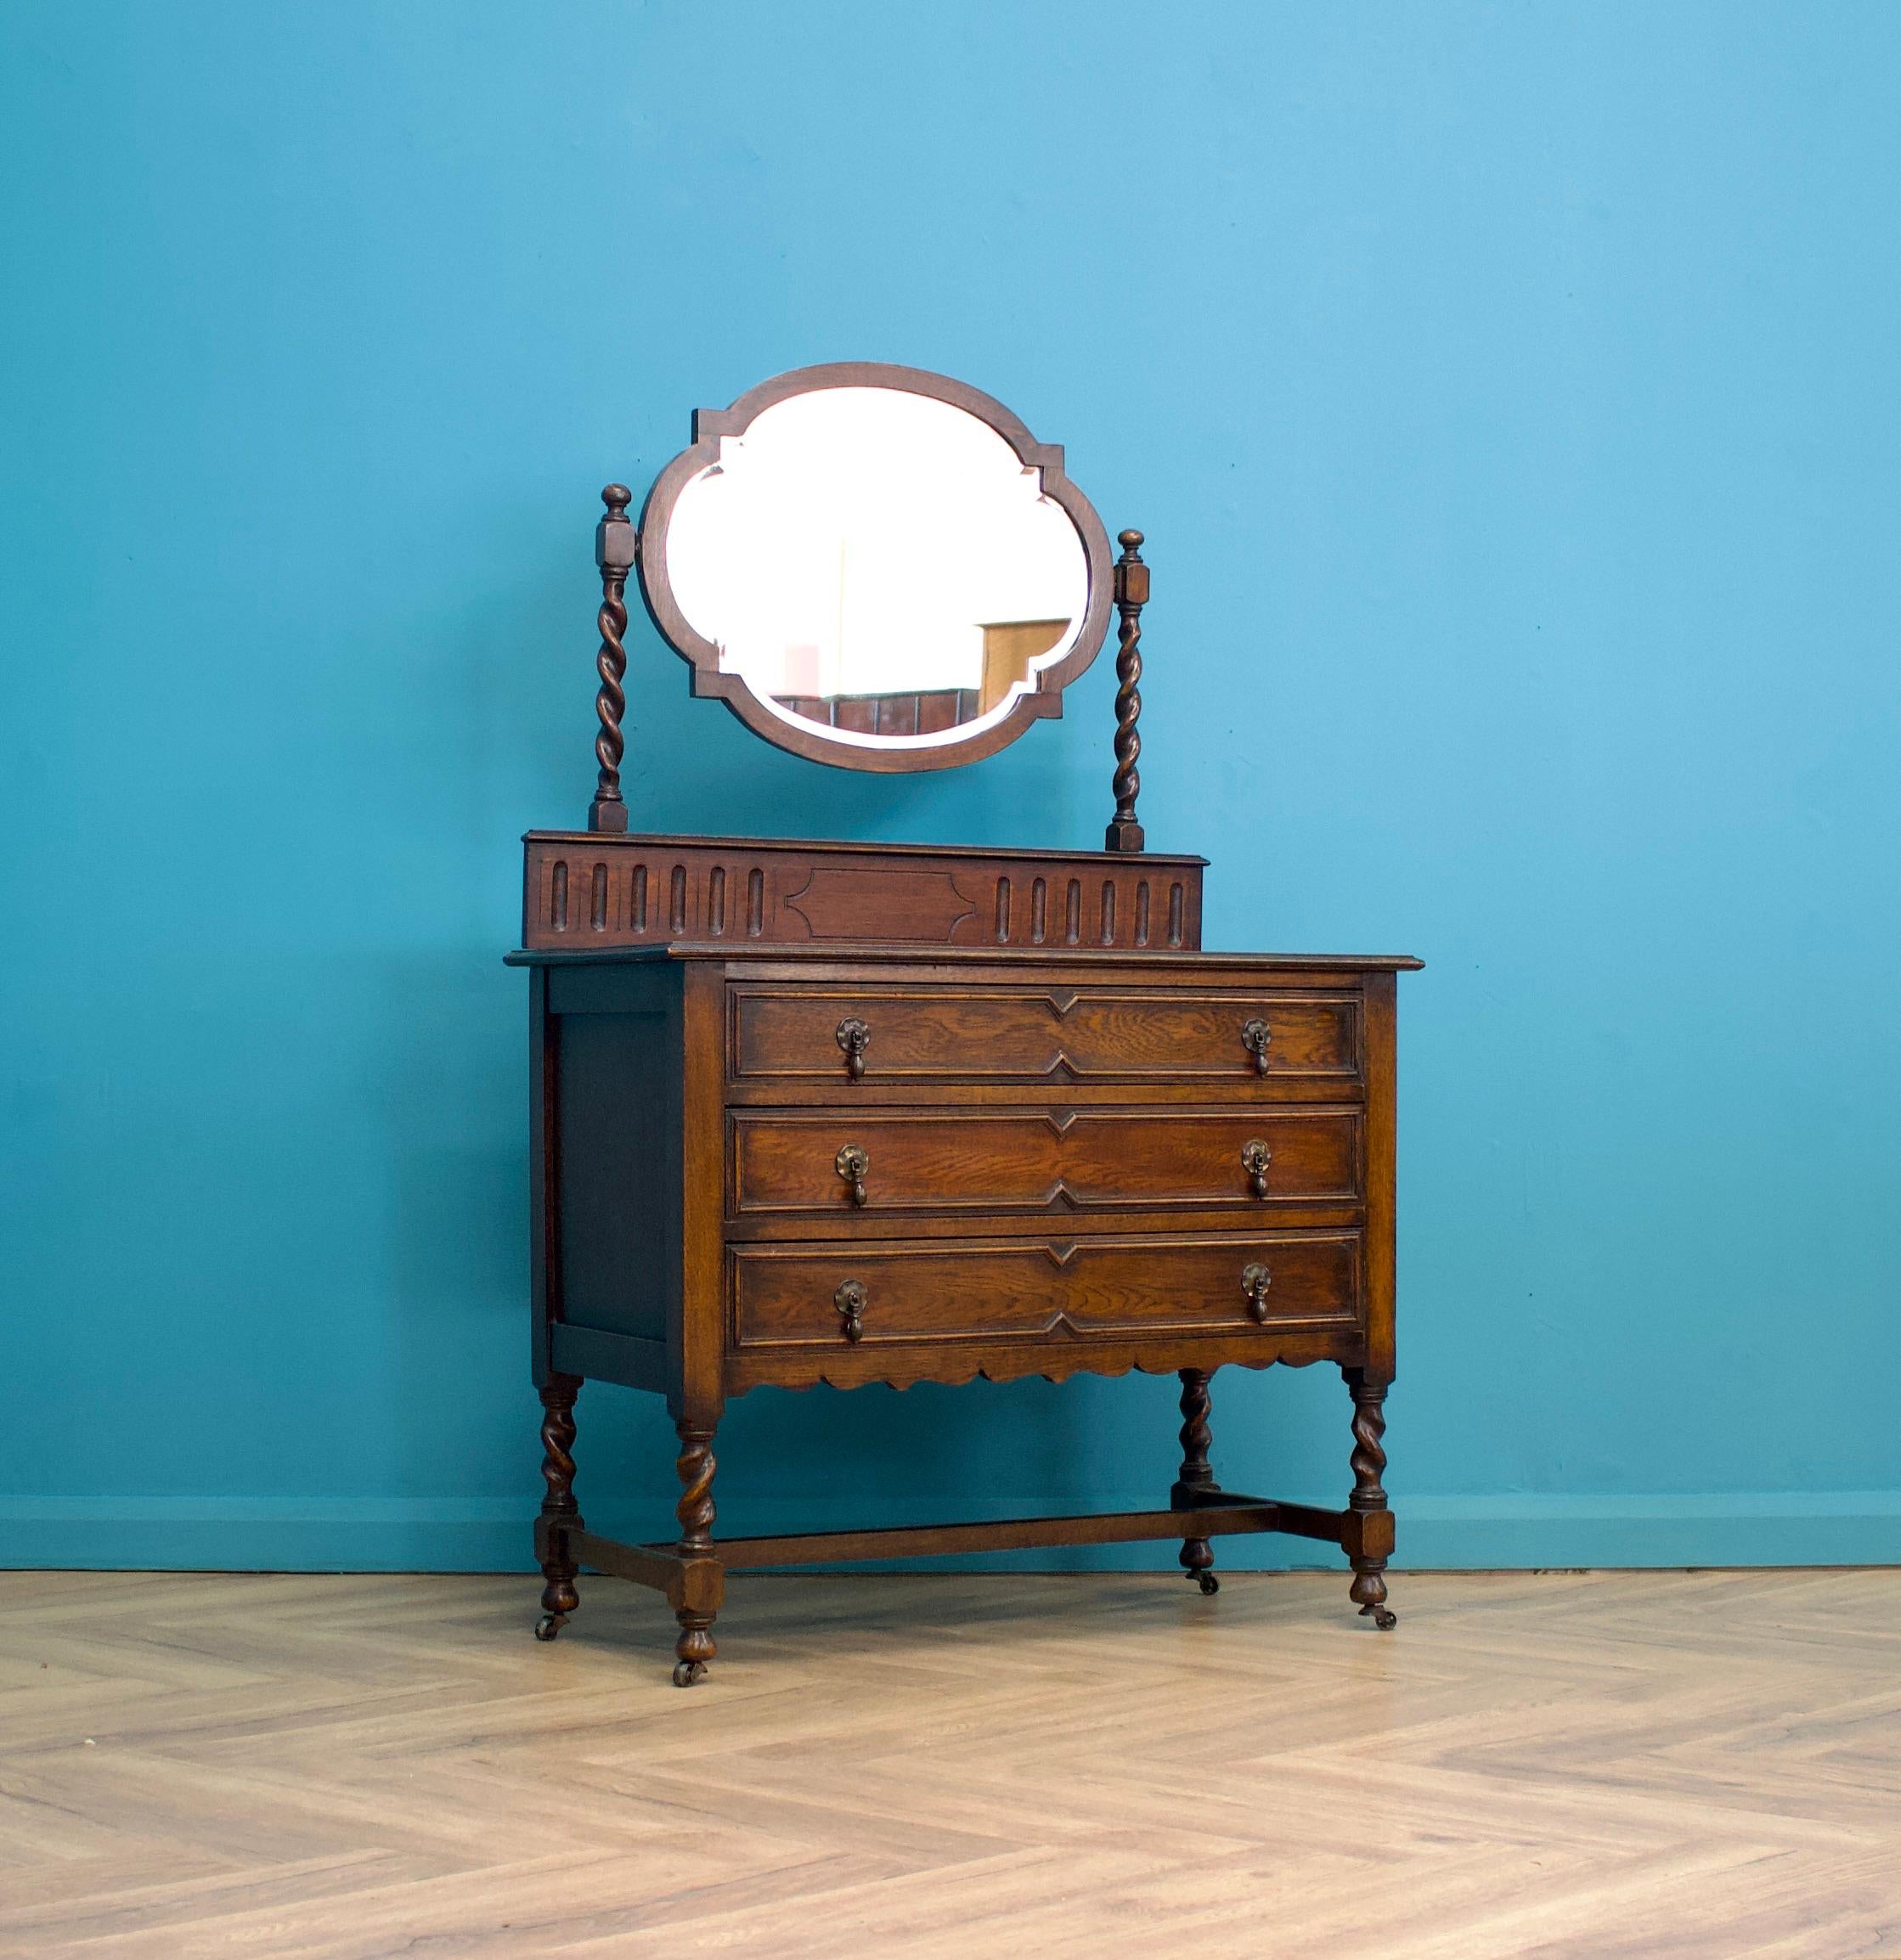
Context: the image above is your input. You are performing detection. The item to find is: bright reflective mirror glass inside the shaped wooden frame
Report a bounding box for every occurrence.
[666,388,1090,746]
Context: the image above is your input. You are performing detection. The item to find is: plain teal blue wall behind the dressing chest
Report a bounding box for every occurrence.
[0,0,1901,1566]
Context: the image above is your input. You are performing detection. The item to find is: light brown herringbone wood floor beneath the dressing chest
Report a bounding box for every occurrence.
[0,1570,1901,1960]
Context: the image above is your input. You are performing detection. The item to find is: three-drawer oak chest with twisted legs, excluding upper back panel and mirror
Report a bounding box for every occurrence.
[516,909,1415,1678]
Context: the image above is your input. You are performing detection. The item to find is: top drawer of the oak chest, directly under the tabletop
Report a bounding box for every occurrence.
[727,982,1360,1088]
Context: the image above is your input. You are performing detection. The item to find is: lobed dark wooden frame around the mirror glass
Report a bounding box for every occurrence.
[639,361,1111,774]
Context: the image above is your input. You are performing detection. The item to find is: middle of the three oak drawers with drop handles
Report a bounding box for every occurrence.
[727,1106,1362,1219]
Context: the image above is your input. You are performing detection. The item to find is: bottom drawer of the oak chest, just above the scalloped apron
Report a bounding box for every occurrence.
[727,1231,1360,1349]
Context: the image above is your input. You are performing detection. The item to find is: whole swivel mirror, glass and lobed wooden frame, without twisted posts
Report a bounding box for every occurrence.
[623,363,1109,770]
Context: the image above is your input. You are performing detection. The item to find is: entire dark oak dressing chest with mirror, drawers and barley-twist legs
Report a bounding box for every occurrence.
[510,364,1419,1686]
